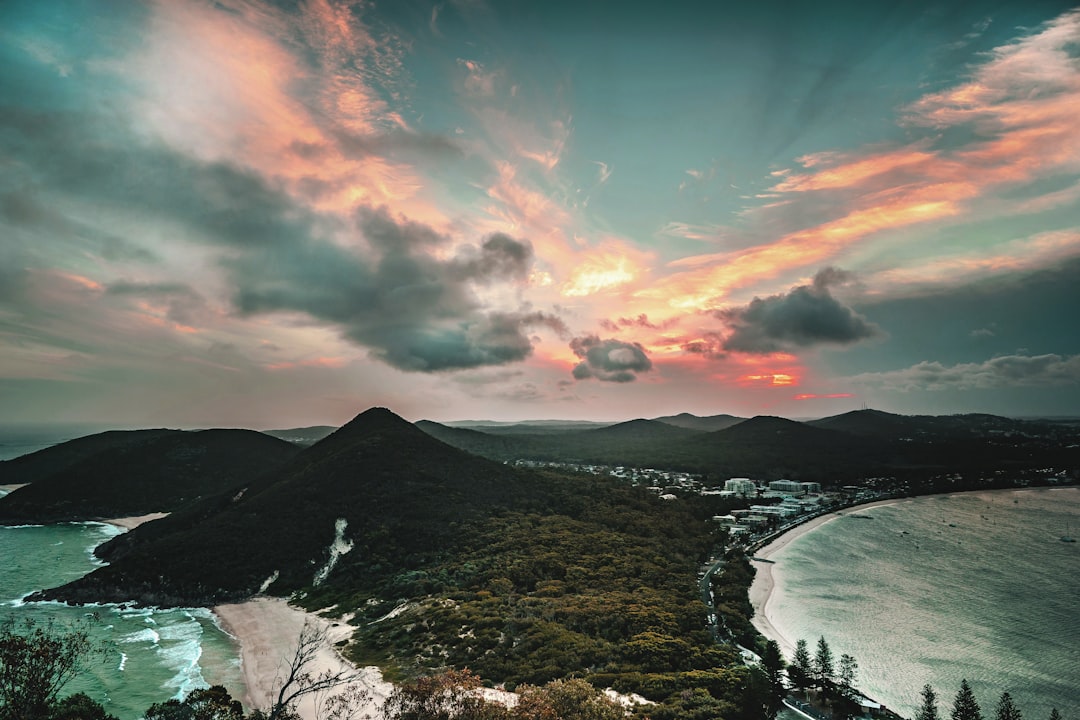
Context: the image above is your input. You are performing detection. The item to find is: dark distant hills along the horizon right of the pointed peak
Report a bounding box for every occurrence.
[417,410,1080,484]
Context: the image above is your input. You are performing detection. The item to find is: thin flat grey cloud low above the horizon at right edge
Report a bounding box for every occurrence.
[849,354,1080,392]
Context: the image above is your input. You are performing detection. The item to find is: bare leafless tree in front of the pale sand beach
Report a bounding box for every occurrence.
[265,621,366,720]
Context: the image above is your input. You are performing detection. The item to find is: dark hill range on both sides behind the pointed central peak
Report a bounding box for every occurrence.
[0,409,1080,524]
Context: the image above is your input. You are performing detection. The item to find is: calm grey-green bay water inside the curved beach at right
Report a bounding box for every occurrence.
[768,488,1080,720]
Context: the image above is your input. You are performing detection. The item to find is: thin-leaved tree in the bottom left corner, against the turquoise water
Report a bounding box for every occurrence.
[0,617,96,720]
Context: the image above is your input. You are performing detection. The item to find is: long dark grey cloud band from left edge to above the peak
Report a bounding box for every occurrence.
[0,107,566,371]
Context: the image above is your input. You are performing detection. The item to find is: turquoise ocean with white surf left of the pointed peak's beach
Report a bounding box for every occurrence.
[0,490,244,720]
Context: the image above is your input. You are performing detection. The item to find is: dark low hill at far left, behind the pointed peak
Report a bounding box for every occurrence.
[0,430,299,525]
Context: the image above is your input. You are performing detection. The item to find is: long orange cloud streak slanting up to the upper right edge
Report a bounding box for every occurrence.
[638,12,1080,311]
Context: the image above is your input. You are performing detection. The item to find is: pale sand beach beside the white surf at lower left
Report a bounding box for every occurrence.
[214,597,393,720]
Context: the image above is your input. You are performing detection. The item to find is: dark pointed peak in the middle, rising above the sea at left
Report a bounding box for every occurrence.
[35,408,550,604]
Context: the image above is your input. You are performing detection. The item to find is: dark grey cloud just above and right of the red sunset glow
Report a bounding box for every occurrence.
[716,268,880,353]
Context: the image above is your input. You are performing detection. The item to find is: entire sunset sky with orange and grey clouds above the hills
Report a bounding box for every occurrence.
[0,0,1080,429]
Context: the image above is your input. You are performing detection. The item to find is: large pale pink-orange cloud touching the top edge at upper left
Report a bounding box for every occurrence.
[124,0,446,226]
